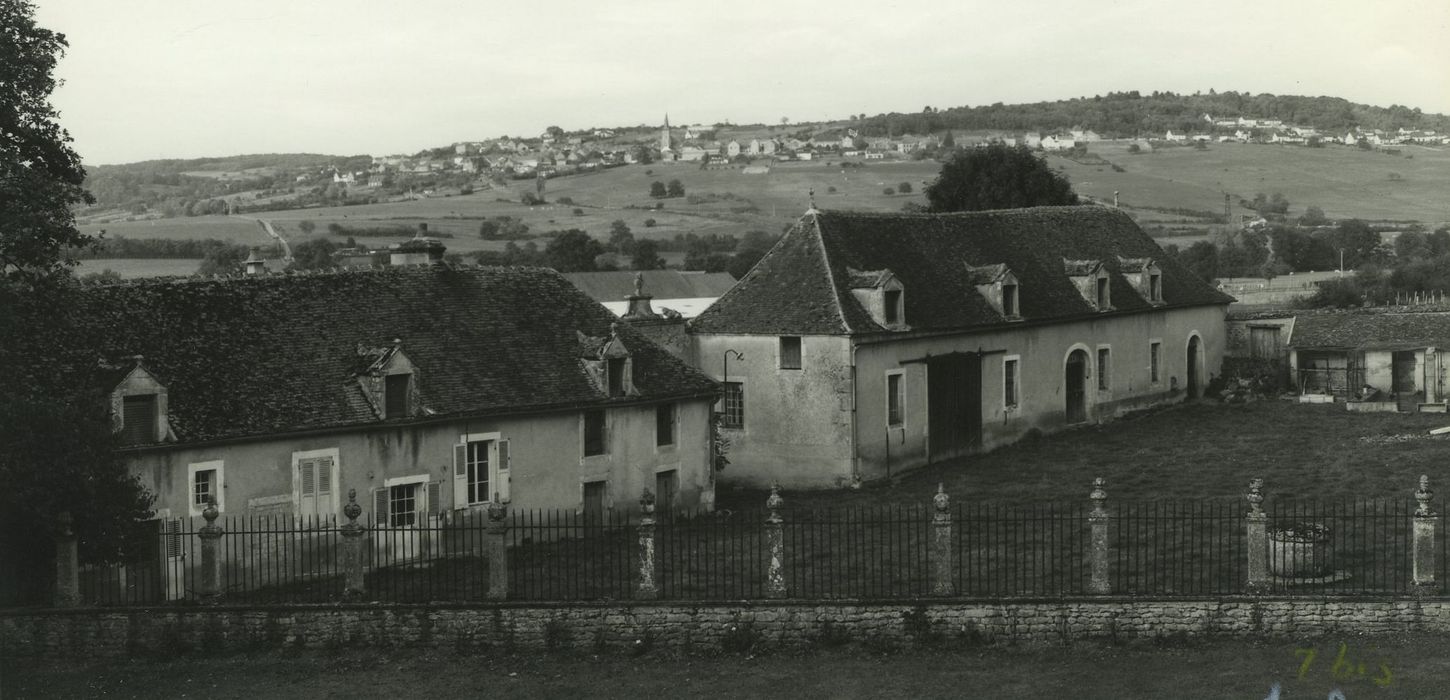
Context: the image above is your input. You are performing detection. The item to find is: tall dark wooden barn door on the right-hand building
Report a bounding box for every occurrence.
[927,352,982,461]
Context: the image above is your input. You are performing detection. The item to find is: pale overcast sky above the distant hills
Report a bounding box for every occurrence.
[33,0,1450,165]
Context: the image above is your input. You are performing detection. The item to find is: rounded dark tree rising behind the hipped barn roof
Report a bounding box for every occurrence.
[927,143,1077,212]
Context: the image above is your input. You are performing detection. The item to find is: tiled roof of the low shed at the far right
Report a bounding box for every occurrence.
[1289,312,1450,349]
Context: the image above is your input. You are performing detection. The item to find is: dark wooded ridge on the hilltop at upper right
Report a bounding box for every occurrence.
[860,90,1450,138]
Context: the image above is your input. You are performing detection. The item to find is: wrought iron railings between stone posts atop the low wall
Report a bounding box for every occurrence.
[0,486,1450,606]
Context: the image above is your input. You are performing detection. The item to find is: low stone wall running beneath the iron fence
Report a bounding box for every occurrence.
[0,597,1450,658]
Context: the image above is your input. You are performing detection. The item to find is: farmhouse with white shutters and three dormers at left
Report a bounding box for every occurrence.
[46,265,718,539]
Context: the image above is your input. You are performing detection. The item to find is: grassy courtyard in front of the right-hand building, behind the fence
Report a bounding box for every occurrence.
[718,400,1450,507]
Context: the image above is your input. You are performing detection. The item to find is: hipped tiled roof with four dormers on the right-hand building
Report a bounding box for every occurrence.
[690,206,1233,335]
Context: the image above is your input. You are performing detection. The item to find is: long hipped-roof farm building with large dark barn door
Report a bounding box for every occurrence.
[690,206,1233,488]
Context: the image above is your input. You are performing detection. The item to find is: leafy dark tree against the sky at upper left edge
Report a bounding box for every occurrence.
[0,0,96,278]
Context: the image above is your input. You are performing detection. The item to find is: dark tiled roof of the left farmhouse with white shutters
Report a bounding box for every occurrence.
[12,265,715,442]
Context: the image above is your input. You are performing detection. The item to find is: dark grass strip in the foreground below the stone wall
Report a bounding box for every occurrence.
[0,636,1450,700]
